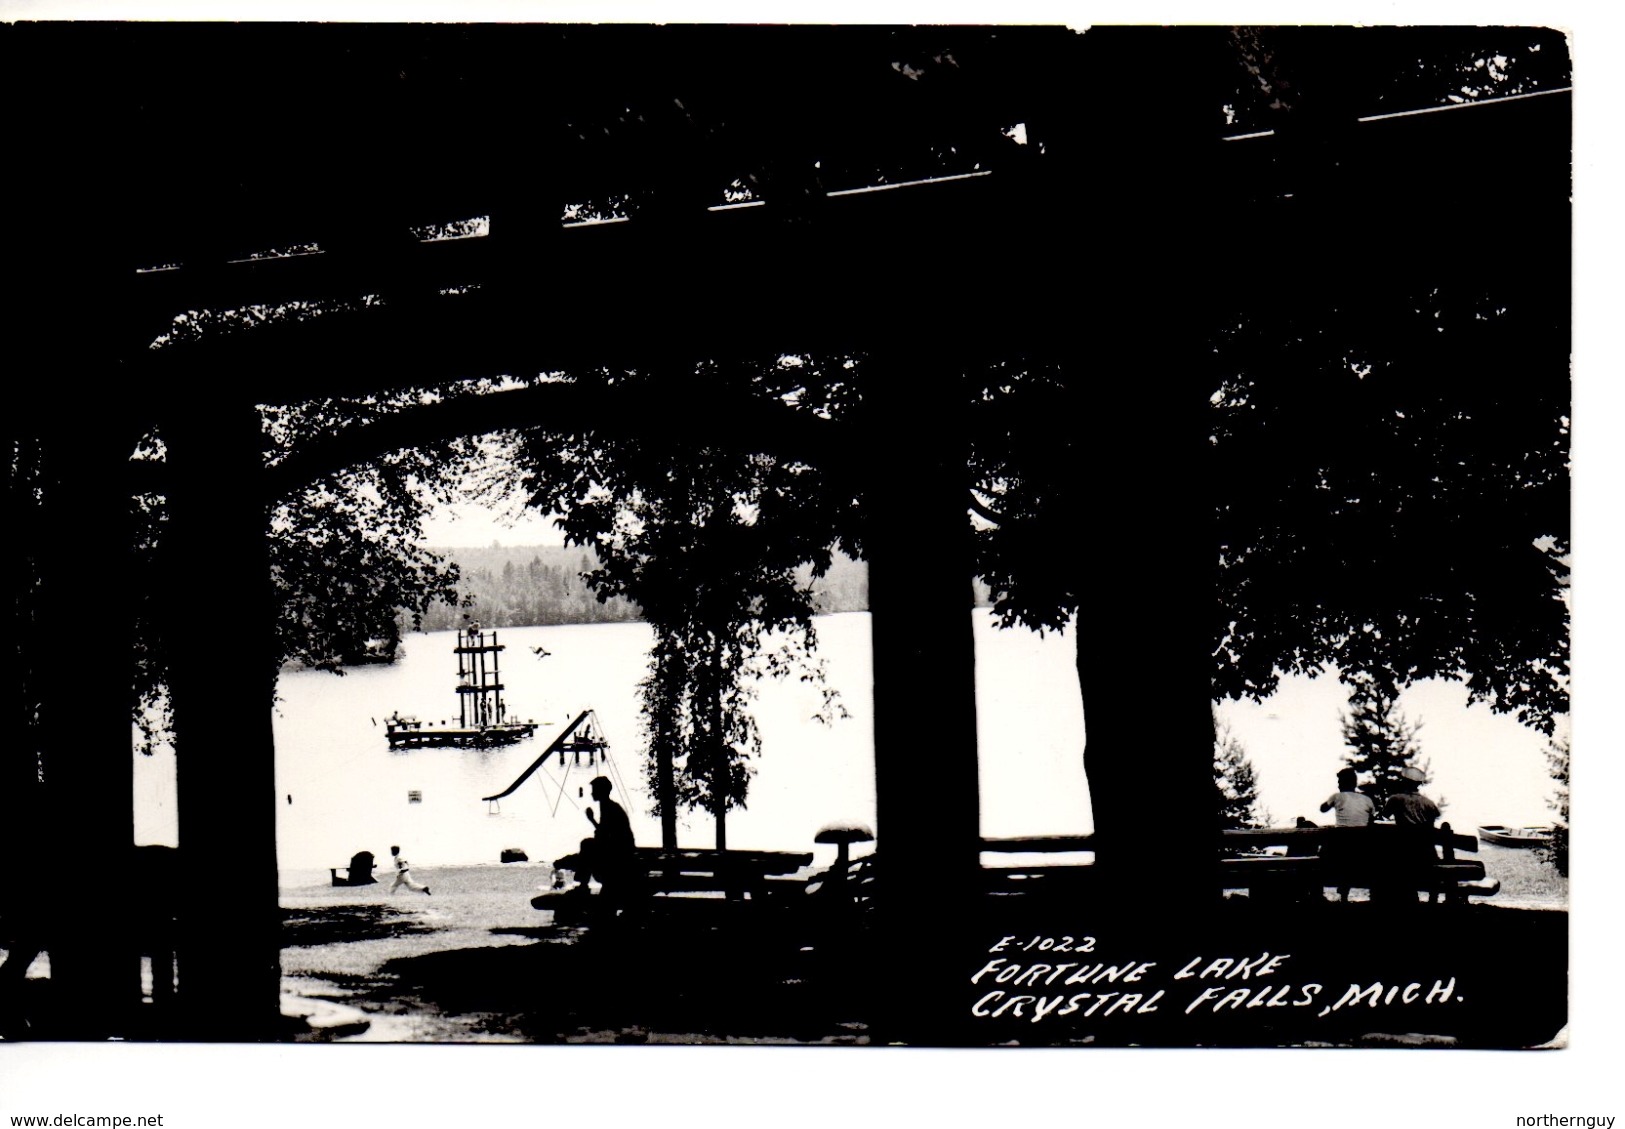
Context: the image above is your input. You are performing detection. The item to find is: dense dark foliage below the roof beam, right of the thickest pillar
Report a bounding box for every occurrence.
[1214,288,1568,733]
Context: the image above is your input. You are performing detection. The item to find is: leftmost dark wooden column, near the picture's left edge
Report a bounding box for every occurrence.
[16,438,141,1040]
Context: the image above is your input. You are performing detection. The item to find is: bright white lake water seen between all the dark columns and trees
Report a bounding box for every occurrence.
[135,612,1550,880]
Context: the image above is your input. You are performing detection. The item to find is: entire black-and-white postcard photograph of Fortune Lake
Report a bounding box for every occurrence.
[0,11,1617,1129]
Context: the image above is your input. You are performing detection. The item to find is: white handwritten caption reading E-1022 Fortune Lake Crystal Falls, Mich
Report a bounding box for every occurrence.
[970,934,1463,1023]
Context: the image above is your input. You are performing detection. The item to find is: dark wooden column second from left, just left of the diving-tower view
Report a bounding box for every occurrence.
[164,394,280,1041]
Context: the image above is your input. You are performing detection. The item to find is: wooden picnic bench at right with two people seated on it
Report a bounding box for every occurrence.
[1217,824,1502,903]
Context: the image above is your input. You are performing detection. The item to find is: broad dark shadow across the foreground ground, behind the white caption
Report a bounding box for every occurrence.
[346,898,1568,1048]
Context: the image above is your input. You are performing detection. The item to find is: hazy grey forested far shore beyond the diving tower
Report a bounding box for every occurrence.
[419,544,869,632]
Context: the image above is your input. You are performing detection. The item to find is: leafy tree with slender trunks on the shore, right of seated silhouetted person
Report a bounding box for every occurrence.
[520,357,858,848]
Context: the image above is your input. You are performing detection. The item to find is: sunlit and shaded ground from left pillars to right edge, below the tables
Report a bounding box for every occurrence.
[283,848,1568,1046]
